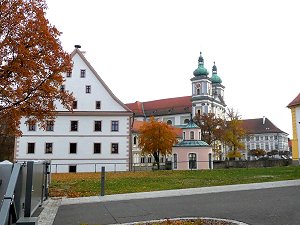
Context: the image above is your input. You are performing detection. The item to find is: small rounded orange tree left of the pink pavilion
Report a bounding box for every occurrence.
[139,117,177,169]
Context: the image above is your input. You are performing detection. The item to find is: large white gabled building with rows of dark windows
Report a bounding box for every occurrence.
[15,48,132,173]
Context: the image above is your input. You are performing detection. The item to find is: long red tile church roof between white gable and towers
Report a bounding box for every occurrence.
[125,96,192,117]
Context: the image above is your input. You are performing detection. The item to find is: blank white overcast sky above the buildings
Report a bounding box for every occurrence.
[46,0,300,138]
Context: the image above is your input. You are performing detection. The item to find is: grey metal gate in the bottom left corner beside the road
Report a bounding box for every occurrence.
[0,161,50,225]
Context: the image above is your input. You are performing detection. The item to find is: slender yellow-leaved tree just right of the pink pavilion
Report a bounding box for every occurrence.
[223,109,246,158]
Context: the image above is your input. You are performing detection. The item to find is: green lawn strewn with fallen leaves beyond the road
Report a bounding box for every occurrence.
[50,166,300,197]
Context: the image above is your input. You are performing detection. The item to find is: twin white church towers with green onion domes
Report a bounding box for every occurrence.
[191,52,226,117]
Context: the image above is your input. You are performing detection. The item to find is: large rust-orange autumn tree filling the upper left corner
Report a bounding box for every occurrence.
[0,0,74,136]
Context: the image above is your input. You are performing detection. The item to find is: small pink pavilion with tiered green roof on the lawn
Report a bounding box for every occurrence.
[172,120,213,170]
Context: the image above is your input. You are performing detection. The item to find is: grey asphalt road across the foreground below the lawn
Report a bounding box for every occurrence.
[53,186,300,225]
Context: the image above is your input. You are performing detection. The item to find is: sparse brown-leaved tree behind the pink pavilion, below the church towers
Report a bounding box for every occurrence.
[194,113,225,158]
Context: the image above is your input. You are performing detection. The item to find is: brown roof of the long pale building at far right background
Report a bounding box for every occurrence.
[242,118,287,134]
